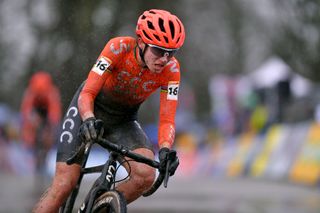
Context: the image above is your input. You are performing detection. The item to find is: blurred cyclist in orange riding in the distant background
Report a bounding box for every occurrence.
[21,71,61,169]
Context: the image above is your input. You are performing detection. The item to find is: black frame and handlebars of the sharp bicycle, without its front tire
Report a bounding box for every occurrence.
[60,138,170,213]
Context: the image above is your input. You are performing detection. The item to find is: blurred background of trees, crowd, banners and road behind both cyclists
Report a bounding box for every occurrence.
[0,0,320,213]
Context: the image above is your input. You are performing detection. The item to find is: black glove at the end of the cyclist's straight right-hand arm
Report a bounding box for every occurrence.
[159,147,179,176]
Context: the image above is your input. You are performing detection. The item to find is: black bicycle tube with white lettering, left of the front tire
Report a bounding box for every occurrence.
[78,152,118,213]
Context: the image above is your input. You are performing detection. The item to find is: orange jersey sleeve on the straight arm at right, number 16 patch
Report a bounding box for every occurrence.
[158,60,180,148]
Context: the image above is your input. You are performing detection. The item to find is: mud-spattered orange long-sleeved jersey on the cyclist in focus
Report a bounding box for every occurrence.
[78,37,180,145]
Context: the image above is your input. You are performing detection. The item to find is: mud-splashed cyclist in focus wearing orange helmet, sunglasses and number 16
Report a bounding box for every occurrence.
[34,9,185,212]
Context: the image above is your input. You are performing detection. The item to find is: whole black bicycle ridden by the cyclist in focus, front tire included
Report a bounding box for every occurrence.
[59,124,176,213]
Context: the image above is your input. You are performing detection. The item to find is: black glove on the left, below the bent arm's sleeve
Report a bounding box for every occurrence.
[79,117,104,141]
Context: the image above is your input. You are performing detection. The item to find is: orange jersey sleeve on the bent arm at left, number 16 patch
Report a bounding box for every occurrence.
[78,37,126,120]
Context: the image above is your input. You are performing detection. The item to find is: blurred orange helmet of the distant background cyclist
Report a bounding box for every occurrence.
[29,71,52,93]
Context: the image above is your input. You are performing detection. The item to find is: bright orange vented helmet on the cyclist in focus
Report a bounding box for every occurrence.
[136,9,185,49]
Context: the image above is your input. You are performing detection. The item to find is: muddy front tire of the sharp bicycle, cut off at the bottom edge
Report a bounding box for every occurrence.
[92,190,127,213]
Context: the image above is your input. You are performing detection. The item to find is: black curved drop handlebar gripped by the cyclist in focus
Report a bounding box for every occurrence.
[66,137,170,197]
